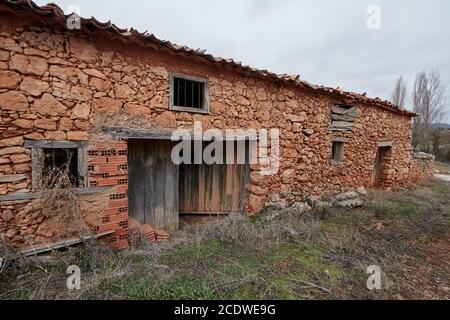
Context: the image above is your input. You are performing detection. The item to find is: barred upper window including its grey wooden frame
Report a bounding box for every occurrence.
[170,74,209,113]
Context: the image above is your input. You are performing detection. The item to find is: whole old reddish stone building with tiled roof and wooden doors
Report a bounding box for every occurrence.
[0,0,433,248]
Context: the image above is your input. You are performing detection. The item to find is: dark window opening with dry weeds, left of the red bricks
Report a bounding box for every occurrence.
[42,149,80,187]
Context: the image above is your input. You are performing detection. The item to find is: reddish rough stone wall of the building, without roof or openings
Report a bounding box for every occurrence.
[0,20,431,247]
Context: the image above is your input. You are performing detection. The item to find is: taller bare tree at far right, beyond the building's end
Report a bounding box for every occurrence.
[412,69,445,152]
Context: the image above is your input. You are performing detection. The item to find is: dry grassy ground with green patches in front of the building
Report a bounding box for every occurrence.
[0,181,450,299]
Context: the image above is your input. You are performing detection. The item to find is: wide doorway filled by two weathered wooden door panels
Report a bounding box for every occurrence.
[128,139,250,231]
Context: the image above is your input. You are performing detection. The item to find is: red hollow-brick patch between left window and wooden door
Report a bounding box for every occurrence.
[88,141,128,249]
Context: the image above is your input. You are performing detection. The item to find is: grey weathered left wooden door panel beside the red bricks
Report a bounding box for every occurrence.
[128,140,179,231]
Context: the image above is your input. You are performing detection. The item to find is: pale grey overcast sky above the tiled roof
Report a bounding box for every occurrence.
[36,0,450,122]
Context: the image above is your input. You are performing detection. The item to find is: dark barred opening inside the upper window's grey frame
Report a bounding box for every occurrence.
[172,77,206,110]
